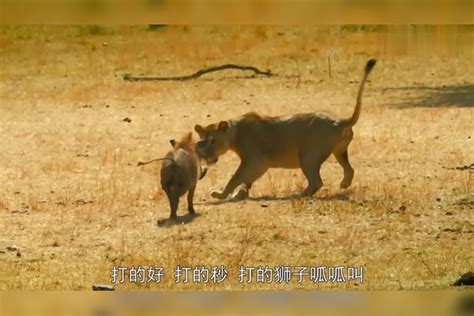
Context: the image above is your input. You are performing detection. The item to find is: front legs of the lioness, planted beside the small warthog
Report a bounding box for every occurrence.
[211,161,268,199]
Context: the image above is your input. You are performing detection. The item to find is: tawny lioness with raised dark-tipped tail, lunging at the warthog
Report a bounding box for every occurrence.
[194,59,376,199]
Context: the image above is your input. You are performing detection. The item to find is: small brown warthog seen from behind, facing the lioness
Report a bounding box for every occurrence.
[138,132,207,220]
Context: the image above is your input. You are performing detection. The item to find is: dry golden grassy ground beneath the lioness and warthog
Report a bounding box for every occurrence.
[0,26,474,289]
